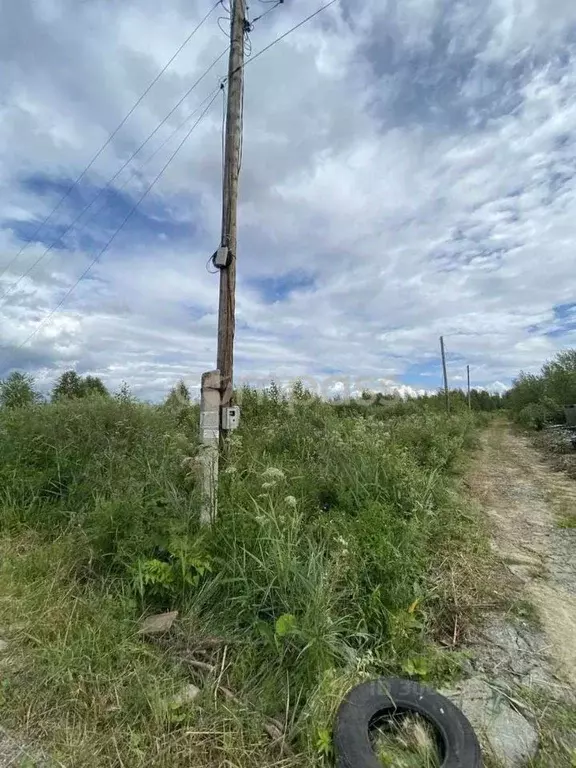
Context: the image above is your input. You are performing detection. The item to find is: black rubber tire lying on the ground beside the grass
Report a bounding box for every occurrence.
[334,678,482,768]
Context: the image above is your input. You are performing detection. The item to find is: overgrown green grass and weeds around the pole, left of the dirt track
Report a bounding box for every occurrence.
[0,388,487,768]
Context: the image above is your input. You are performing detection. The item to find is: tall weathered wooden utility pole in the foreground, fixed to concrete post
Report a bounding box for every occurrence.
[217,0,246,426]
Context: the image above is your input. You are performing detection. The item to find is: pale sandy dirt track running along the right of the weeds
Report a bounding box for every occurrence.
[470,424,576,686]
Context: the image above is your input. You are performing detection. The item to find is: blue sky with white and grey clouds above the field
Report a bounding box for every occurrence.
[0,0,576,398]
